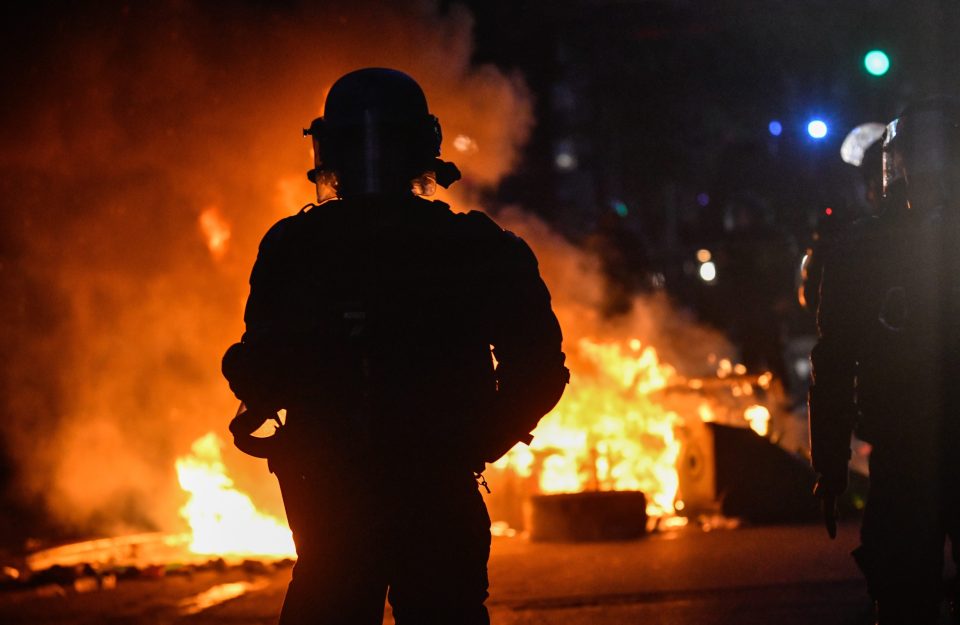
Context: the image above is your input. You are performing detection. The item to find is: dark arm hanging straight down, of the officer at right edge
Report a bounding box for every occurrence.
[809,255,864,496]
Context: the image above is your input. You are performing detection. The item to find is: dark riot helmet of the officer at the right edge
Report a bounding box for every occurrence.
[883,97,960,210]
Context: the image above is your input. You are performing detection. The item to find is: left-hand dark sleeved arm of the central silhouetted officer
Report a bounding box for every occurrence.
[222,218,293,411]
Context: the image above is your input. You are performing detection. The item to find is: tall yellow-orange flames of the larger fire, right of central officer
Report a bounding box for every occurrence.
[494,338,681,516]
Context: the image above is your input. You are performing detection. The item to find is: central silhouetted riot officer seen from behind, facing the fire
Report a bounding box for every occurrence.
[223,68,568,625]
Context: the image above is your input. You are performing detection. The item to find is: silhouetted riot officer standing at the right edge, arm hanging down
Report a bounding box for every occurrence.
[810,98,960,625]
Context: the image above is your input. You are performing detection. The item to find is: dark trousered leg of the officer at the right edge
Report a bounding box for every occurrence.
[854,437,944,625]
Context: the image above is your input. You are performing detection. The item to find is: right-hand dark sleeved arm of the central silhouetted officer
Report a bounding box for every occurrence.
[484,227,569,462]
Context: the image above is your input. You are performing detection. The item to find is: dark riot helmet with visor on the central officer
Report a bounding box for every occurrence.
[303,67,460,202]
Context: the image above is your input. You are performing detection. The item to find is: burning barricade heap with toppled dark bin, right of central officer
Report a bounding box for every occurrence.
[480,339,812,540]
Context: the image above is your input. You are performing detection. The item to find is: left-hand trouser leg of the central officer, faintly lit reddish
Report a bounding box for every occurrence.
[276,458,387,625]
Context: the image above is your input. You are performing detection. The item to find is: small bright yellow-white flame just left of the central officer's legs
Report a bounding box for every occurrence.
[177,432,296,557]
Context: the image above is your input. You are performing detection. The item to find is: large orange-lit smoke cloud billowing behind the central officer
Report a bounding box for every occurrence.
[0,0,736,533]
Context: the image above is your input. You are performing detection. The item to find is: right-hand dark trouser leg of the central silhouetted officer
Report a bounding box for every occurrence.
[389,473,490,625]
